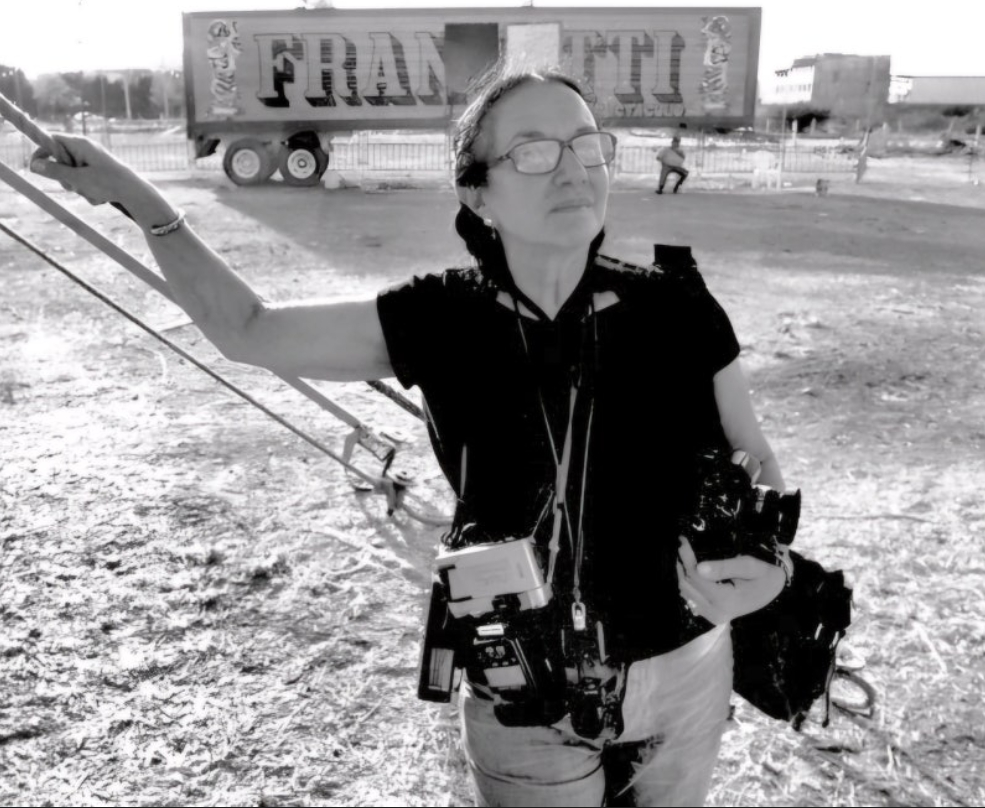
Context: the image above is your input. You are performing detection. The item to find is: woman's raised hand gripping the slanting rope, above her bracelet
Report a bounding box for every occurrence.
[31,135,154,213]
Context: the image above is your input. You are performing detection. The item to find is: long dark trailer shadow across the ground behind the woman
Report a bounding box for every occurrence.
[188,178,985,280]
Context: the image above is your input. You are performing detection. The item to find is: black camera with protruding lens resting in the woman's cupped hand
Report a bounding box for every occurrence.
[680,448,801,564]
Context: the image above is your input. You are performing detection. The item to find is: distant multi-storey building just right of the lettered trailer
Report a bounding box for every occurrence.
[760,53,890,122]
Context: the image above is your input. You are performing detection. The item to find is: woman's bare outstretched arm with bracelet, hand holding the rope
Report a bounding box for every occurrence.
[31,136,393,381]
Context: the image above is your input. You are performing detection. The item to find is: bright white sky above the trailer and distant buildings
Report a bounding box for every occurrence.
[0,0,985,81]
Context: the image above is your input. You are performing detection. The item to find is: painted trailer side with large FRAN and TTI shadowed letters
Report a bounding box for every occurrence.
[184,7,761,137]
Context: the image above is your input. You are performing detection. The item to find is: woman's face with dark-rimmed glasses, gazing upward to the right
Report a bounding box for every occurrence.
[474,81,609,250]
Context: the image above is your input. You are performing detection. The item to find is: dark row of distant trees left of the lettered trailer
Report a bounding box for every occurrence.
[0,64,185,120]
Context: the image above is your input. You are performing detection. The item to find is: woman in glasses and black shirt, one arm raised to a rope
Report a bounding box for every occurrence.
[32,66,785,805]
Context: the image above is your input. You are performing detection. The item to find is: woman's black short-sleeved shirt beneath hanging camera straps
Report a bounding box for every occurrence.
[377,257,739,661]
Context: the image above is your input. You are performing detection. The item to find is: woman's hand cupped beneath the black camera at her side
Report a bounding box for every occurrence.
[677,536,787,625]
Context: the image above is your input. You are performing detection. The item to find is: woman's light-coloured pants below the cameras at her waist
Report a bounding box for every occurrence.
[461,624,732,806]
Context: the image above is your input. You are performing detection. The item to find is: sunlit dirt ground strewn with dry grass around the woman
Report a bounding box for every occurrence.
[0,153,985,806]
